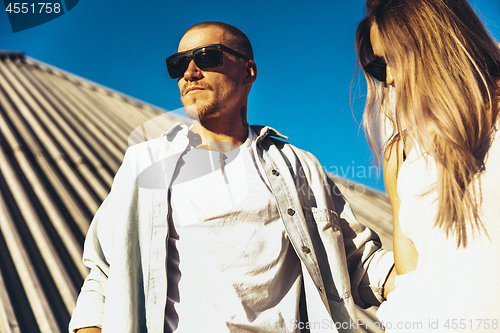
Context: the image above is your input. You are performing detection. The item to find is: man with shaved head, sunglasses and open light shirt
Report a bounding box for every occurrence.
[70,22,393,333]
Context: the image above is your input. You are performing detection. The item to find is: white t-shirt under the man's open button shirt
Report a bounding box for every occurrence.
[166,129,301,333]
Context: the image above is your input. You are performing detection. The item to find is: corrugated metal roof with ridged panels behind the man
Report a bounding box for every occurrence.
[0,51,392,333]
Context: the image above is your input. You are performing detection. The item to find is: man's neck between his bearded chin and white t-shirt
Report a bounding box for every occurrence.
[188,119,248,152]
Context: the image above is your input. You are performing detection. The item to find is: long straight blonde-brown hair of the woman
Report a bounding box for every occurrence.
[356,0,500,247]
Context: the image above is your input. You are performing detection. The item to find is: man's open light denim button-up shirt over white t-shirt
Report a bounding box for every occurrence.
[69,124,393,333]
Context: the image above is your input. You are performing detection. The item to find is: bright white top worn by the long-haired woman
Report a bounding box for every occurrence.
[377,128,500,332]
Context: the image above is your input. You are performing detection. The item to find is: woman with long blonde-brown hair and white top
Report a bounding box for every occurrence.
[356,0,500,332]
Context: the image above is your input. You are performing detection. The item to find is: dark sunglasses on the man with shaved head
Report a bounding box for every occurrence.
[167,44,250,79]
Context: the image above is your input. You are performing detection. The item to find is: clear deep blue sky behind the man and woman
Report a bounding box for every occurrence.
[0,0,500,190]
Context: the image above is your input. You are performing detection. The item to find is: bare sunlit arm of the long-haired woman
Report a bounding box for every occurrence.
[383,140,418,275]
